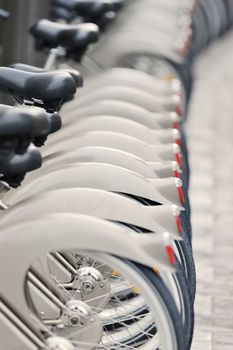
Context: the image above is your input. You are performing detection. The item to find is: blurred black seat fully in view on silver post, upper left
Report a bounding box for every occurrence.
[31,19,99,51]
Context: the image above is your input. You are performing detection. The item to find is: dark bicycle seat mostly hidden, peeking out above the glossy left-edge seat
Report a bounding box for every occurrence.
[9,63,83,88]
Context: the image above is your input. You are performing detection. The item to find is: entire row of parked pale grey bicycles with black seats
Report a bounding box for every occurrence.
[0,0,230,350]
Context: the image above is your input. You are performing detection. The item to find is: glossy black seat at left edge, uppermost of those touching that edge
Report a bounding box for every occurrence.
[0,67,77,102]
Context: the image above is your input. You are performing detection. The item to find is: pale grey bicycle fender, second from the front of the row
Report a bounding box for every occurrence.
[0,188,181,240]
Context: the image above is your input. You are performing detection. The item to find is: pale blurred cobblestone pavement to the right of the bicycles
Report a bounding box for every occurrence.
[187,32,233,350]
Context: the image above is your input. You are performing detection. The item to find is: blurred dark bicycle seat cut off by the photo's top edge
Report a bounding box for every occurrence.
[52,0,119,18]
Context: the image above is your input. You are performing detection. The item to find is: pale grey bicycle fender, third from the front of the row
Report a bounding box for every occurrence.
[4,163,182,209]
